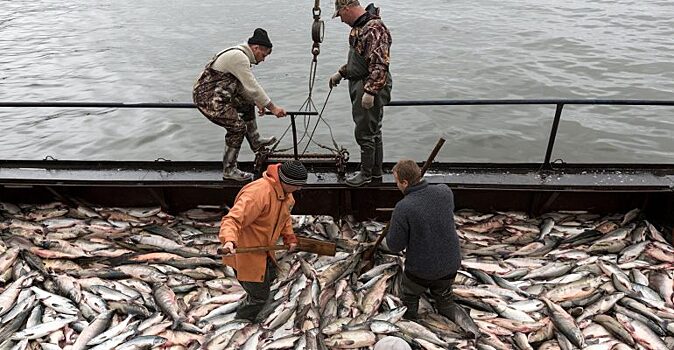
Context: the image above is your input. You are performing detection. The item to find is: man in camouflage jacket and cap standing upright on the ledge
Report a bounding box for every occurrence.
[330,0,392,186]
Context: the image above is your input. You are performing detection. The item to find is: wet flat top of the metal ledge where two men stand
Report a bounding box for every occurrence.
[0,161,674,192]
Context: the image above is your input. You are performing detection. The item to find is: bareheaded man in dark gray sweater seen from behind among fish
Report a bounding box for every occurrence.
[385,160,461,319]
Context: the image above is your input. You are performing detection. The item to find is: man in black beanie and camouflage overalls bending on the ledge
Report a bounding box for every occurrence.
[192,28,286,181]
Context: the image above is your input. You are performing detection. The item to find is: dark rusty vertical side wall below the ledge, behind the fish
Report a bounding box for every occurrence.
[0,184,674,235]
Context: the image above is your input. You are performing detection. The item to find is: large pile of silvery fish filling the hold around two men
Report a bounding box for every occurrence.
[0,202,674,350]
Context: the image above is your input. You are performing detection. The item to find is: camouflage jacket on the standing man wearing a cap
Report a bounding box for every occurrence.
[339,12,391,95]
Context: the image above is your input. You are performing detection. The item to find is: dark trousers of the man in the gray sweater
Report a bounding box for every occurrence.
[400,271,456,320]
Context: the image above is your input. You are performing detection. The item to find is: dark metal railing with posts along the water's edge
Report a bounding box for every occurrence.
[0,99,674,170]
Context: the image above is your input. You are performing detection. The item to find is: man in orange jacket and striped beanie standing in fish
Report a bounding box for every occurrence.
[219,160,307,322]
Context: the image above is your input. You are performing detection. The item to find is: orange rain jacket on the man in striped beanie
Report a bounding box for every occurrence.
[219,164,297,282]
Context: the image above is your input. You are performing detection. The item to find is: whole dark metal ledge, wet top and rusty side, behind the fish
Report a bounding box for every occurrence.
[0,161,674,232]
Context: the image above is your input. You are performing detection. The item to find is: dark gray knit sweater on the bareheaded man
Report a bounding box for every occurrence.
[386,180,461,280]
